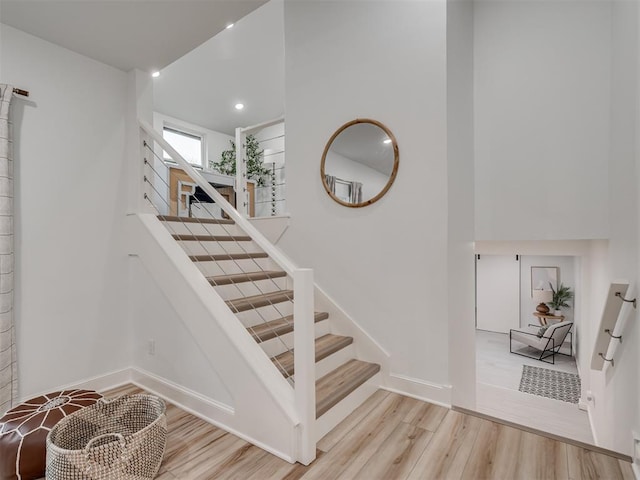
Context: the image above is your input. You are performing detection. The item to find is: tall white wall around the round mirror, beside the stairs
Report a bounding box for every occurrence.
[279,1,450,394]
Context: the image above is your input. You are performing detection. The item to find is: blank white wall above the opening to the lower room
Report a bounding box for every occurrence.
[474,0,612,240]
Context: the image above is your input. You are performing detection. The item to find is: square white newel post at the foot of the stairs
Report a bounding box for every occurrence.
[293,268,316,465]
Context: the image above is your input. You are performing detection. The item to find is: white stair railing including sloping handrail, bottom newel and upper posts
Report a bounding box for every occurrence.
[139,119,316,465]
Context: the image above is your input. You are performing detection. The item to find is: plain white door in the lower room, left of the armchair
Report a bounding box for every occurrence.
[476,255,520,333]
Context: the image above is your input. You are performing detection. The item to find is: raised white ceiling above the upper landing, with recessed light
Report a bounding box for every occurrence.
[153,0,284,135]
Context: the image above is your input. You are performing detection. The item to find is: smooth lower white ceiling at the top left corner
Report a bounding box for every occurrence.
[0,0,266,71]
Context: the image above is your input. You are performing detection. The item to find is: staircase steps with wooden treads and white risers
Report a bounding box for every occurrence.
[158,215,380,439]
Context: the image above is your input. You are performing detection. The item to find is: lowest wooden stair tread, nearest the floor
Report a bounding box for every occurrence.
[316,359,380,418]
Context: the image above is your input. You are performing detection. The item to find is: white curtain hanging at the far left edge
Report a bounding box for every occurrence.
[0,84,18,415]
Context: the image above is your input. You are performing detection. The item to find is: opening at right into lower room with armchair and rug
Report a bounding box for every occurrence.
[475,254,594,444]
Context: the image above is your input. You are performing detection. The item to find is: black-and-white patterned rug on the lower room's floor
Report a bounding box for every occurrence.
[518,365,580,403]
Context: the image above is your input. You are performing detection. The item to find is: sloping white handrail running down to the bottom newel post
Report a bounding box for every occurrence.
[138,119,297,277]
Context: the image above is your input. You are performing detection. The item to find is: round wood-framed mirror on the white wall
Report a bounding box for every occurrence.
[320,118,399,208]
